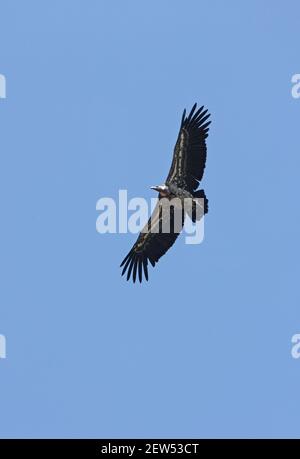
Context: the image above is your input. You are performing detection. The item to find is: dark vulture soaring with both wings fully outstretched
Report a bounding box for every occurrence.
[121,104,211,282]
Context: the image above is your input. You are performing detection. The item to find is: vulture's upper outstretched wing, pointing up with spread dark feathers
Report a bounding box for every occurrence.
[166,104,211,192]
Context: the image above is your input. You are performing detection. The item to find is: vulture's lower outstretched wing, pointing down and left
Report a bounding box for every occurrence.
[120,200,185,282]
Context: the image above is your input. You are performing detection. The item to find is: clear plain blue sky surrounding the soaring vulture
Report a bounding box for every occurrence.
[0,0,300,438]
